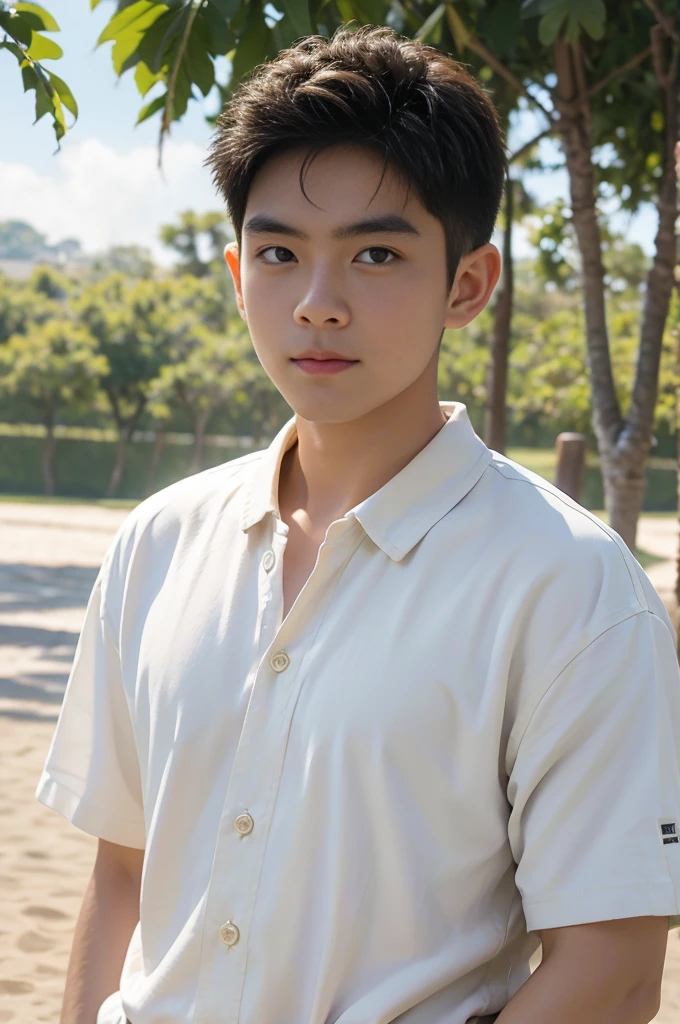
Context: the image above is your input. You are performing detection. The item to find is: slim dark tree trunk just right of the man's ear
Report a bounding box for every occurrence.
[484,175,514,455]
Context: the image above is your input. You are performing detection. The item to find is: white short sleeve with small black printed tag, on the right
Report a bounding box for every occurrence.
[507,609,680,932]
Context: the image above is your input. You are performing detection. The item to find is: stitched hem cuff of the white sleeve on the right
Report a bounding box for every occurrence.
[522,879,680,932]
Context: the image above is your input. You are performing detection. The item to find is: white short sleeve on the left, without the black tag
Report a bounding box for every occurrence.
[36,568,145,849]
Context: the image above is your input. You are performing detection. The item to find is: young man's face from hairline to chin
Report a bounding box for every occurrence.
[225,145,489,423]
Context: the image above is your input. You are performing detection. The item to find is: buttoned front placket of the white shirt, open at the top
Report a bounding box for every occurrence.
[194,515,364,1024]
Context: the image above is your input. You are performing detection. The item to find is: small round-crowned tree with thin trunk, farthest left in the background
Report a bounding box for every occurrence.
[0,319,108,495]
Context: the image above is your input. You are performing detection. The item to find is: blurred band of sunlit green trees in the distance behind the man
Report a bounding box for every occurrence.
[0,209,677,505]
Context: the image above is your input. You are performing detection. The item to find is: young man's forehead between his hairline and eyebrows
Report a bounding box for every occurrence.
[246,144,429,220]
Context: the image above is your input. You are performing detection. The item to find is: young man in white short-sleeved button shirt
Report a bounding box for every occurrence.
[38,22,680,1024]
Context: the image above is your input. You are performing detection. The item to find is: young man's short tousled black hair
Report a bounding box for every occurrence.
[206,26,507,288]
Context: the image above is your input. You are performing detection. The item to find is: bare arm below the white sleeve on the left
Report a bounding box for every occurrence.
[60,840,144,1024]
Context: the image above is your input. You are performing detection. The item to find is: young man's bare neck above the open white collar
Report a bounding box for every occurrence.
[279,376,448,536]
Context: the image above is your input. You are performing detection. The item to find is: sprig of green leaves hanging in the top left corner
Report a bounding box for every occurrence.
[0,0,78,150]
